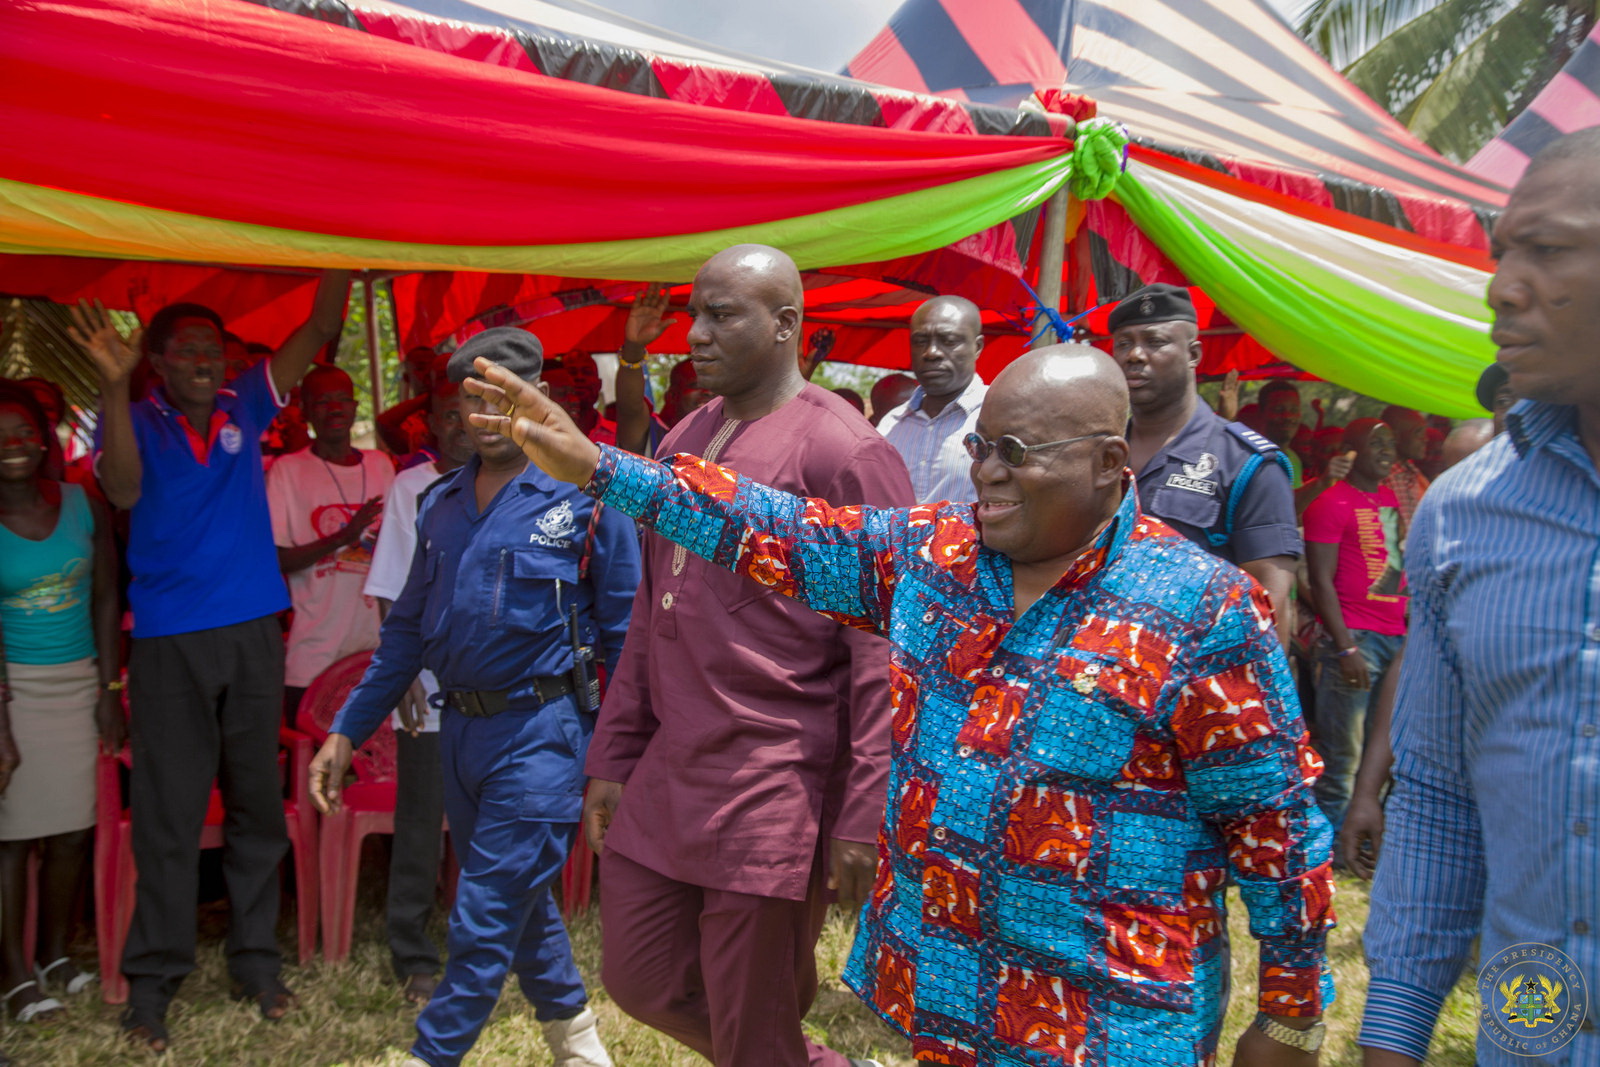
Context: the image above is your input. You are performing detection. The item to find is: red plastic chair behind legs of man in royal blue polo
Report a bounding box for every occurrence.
[94,729,317,1005]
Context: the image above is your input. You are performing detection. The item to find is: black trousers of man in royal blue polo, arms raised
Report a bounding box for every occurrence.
[122,616,290,1011]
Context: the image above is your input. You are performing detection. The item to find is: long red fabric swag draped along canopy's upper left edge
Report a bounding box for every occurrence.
[0,0,1061,245]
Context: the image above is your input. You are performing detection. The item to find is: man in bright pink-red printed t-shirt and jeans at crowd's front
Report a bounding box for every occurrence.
[1306,419,1406,832]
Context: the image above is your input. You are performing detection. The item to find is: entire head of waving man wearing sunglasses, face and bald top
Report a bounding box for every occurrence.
[973,346,1128,563]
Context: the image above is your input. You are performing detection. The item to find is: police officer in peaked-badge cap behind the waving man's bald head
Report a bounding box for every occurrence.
[1110,285,1304,643]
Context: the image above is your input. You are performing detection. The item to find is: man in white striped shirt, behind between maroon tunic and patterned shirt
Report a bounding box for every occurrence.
[878,296,989,504]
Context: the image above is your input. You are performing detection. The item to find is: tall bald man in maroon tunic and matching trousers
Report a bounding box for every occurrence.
[584,245,914,1067]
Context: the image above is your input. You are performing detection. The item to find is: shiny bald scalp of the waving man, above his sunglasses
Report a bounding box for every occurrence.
[984,344,1128,440]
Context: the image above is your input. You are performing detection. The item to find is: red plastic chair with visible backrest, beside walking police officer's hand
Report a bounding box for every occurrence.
[294,653,395,963]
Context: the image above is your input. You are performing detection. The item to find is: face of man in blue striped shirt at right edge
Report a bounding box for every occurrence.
[1488,158,1600,405]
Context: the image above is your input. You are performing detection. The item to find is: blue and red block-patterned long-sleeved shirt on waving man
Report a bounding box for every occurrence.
[590,448,1333,1067]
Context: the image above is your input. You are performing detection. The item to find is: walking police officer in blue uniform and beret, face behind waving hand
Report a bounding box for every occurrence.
[312,328,640,1067]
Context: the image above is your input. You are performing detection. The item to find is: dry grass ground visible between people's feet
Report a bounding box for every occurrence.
[18,877,1475,1067]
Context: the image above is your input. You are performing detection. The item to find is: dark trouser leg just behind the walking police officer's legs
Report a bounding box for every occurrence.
[379,726,445,977]
